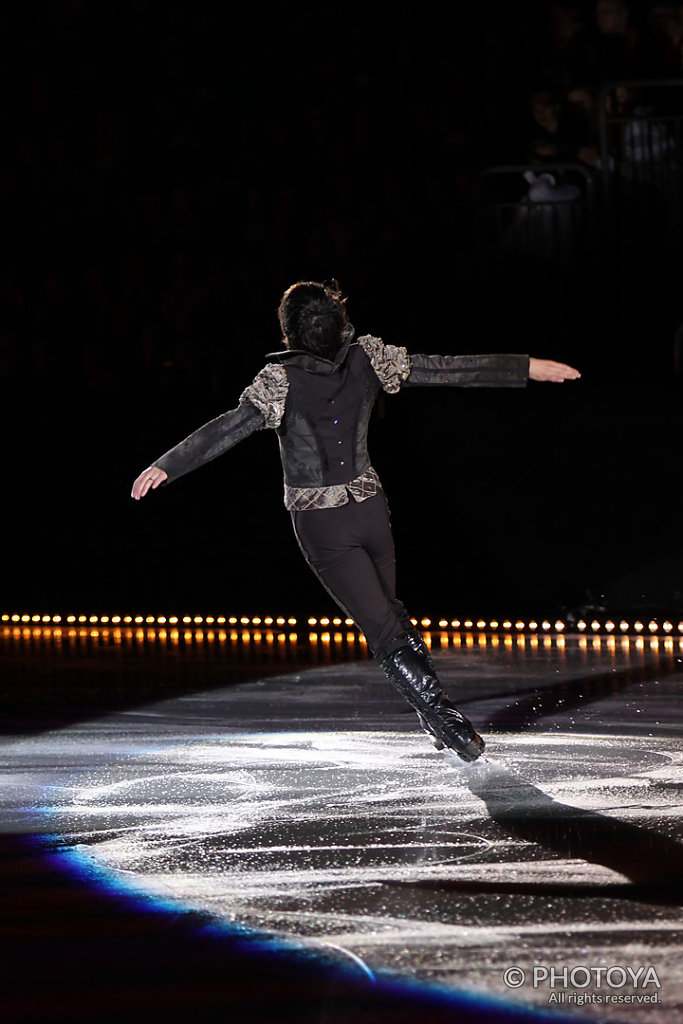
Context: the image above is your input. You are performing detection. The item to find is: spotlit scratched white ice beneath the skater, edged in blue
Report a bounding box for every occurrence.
[3,634,683,1022]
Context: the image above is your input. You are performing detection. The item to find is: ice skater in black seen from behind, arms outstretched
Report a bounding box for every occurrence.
[132,282,581,761]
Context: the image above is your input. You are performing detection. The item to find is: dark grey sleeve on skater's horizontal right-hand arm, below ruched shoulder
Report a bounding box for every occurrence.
[404,354,528,387]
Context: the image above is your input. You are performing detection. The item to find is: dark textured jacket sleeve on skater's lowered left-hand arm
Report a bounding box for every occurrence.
[153,401,265,481]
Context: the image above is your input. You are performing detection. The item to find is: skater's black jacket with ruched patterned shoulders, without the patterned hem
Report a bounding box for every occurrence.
[154,336,528,497]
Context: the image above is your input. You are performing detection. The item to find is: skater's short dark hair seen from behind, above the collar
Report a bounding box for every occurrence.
[278,281,352,359]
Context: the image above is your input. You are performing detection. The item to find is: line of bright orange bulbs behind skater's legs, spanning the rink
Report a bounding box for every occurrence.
[0,612,683,634]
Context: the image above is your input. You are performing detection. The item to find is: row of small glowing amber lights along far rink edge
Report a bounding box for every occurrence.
[0,612,683,636]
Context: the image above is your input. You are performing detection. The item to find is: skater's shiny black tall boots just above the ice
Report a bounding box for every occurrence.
[378,631,484,761]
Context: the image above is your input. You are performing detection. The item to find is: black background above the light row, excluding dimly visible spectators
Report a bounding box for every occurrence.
[0,0,683,615]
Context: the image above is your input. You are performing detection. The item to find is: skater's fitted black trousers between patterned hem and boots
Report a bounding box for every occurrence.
[292,493,408,653]
